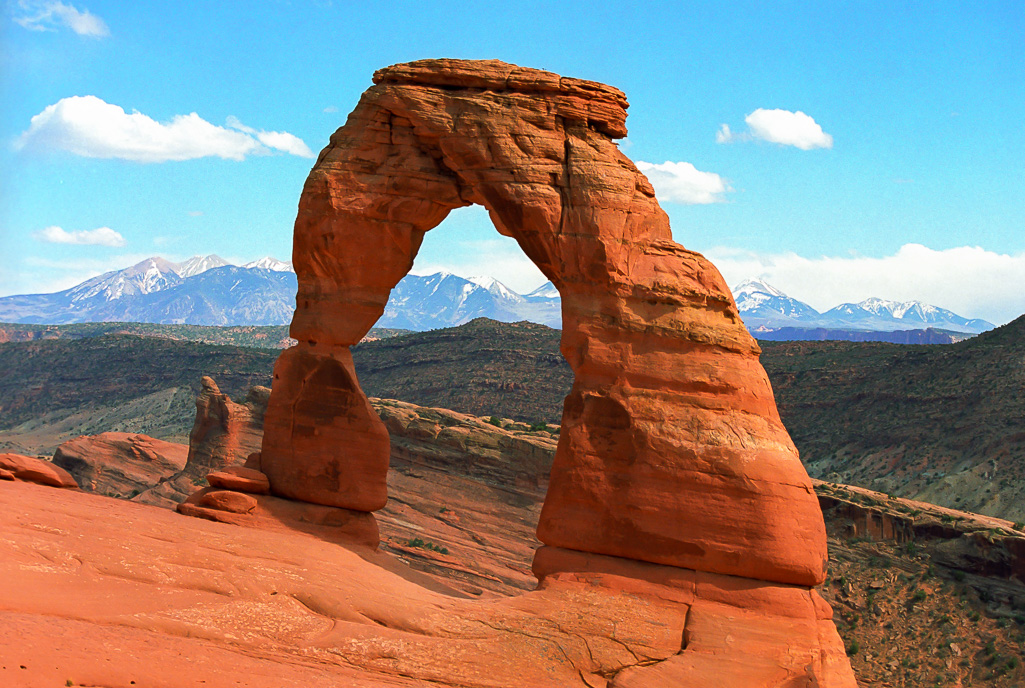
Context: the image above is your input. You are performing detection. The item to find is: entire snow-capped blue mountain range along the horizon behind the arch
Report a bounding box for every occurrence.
[0,255,993,343]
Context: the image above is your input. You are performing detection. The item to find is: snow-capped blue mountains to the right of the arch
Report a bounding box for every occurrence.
[733,279,993,334]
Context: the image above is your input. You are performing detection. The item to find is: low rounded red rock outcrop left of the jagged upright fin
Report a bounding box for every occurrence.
[53,433,189,497]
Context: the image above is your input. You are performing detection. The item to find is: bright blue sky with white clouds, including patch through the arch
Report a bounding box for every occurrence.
[0,0,1025,323]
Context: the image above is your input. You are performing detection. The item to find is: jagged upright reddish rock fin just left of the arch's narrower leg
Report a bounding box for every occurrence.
[137,376,271,507]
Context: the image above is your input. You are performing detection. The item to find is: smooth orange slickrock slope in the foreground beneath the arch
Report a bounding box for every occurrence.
[0,483,854,688]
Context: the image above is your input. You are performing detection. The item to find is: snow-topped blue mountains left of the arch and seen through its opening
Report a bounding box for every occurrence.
[0,255,562,330]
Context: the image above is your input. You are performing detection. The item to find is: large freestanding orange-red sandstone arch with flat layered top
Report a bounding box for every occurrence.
[262,60,825,585]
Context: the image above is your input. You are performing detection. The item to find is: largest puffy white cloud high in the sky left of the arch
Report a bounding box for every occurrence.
[15,95,313,162]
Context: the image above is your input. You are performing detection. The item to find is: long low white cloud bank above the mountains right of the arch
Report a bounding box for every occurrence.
[704,244,1025,325]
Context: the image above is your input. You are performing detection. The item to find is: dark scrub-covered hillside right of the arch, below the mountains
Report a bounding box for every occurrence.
[762,318,1025,520]
